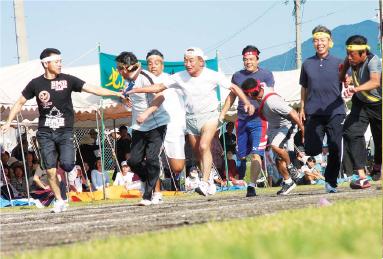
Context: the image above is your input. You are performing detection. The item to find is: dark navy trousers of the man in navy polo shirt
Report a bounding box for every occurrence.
[305,114,345,187]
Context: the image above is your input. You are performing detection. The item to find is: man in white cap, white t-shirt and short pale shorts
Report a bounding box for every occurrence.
[128,47,254,196]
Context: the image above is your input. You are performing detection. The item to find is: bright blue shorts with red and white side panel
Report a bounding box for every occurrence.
[236,118,267,158]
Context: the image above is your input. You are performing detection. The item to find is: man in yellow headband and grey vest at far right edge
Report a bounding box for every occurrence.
[340,35,382,189]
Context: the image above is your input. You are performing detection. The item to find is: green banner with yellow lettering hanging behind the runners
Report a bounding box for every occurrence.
[99,52,218,91]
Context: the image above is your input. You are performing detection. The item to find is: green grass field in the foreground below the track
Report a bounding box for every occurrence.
[11,197,382,259]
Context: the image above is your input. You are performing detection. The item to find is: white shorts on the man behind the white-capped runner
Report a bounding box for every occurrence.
[164,127,185,159]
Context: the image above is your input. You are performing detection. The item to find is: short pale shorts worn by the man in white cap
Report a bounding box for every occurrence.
[186,111,219,136]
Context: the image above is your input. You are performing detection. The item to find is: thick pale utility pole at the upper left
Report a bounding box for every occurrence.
[13,0,28,63]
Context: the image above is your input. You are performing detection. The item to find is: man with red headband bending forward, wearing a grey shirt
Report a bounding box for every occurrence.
[242,78,304,195]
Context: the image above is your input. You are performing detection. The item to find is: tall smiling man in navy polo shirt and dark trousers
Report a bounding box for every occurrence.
[299,25,346,193]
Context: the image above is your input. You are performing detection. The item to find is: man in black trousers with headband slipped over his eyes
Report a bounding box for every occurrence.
[116,52,169,206]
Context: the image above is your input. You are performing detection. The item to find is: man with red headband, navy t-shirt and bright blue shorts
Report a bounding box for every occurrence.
[226,45,274,197]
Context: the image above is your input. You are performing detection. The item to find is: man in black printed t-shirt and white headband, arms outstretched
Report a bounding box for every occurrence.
[1,48,123,213]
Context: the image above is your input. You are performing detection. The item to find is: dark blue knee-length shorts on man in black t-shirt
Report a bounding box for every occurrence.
[36,129,75,172]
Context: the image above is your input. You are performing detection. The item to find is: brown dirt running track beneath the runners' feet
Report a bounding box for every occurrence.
[0,186,381,255]
